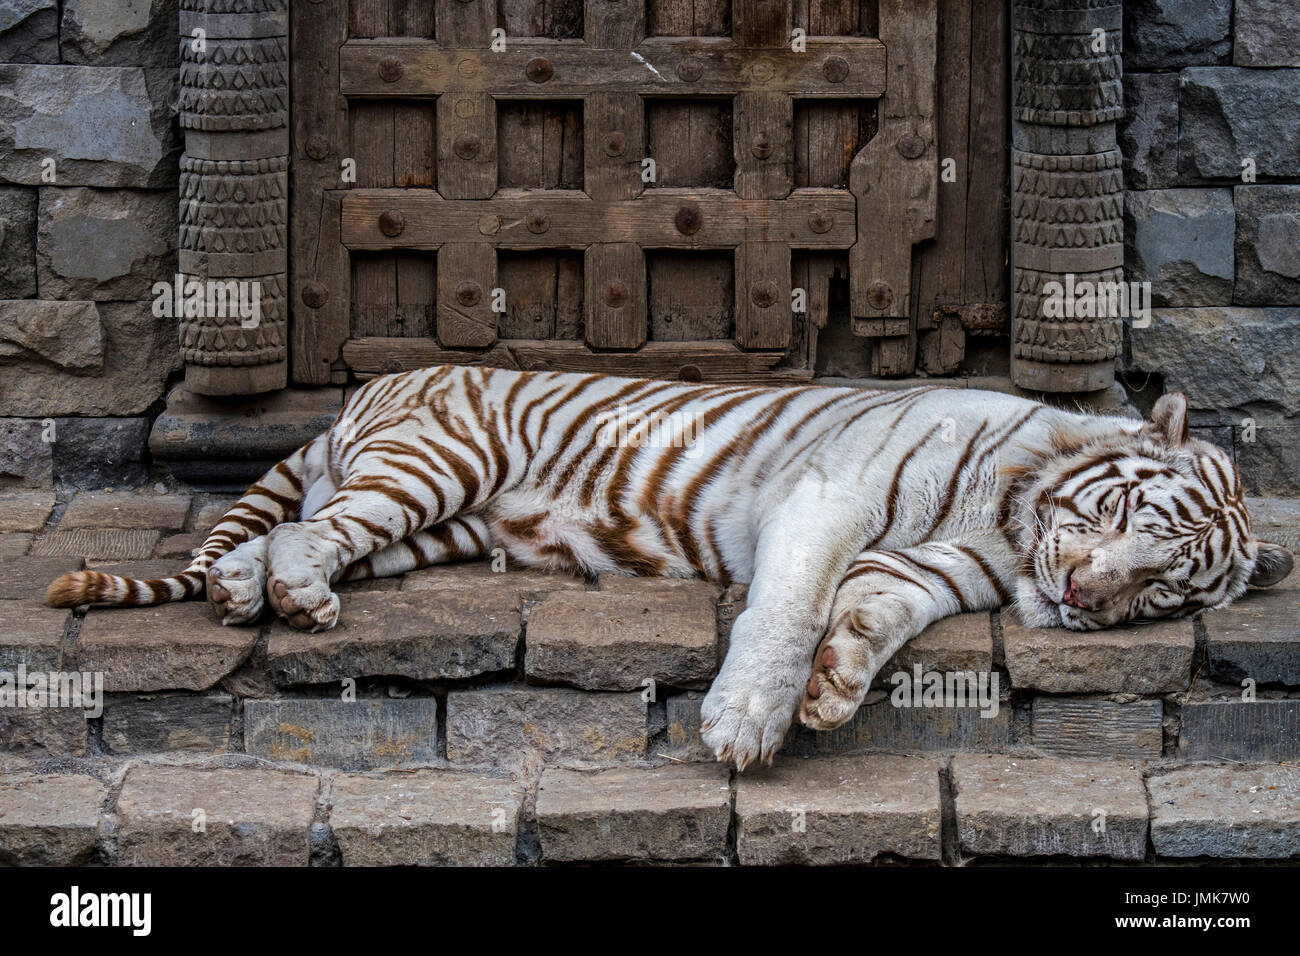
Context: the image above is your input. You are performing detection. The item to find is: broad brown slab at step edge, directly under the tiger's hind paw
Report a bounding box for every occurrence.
[267,591,523,684]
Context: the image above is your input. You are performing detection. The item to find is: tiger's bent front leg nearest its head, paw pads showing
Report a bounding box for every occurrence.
[800,532,1015,730]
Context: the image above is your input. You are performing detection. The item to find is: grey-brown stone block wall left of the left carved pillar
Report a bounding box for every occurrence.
[0,0,181,486]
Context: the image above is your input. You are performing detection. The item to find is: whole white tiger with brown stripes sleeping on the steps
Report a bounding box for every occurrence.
[47,365,1292,769]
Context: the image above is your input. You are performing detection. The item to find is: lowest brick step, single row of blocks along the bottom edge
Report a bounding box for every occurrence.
[0,754,1300,866]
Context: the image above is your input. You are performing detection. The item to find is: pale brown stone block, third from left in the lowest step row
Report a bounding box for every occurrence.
[329,770,524,866]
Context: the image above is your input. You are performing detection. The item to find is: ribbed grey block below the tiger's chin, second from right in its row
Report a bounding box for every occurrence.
[1032,695,1165,760]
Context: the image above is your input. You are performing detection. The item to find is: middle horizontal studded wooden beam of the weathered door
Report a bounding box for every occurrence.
[343,189,857,250]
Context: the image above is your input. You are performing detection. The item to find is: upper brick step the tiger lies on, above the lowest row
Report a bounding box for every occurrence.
[0,554,1300,770]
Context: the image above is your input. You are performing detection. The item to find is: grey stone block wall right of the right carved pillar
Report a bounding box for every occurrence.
[1121,0,1300,494]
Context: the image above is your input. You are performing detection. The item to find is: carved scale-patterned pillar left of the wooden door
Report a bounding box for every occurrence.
[179,0,289,395]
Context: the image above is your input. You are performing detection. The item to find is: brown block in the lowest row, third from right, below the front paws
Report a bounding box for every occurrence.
[736,754,941,865]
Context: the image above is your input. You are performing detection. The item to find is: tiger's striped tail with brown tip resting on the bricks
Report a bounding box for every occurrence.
[46,433,328,607]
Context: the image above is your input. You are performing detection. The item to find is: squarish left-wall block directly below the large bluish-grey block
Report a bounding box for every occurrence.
[36,187,178,303]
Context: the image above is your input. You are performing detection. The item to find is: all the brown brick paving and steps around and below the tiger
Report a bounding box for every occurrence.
[0,490,1300,865]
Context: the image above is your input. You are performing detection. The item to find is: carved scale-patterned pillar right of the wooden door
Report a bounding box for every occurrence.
[1011,0,1125,392]
